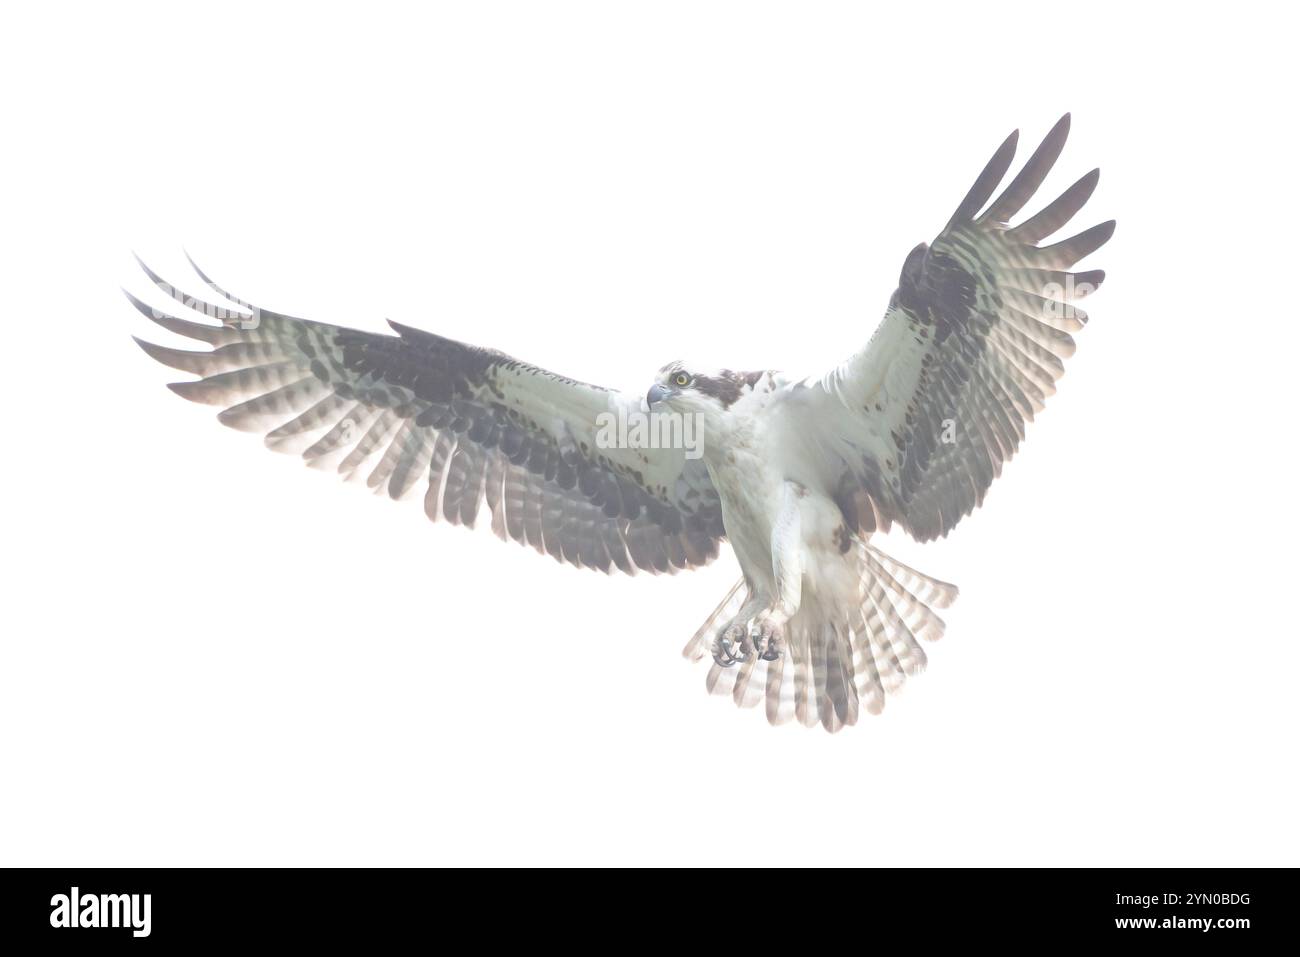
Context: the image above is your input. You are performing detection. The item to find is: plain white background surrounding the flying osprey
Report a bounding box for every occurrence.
[0,3,1300,866]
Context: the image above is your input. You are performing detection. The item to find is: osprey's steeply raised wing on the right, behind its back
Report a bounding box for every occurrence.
[800,114,1115,541]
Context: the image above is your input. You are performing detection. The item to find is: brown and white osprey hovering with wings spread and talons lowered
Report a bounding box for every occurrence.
[127,114,1114,731]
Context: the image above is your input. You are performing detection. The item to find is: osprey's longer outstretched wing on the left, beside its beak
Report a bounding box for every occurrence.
[127,263,724,573]
